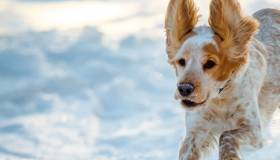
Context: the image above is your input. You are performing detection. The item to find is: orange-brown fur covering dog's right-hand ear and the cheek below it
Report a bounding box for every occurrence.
[209,0,258,81]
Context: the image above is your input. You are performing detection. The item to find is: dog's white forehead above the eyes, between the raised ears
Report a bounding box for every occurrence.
[178,26,217,54]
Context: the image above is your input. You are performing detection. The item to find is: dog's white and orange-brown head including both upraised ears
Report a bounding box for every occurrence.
[165,0,258,109]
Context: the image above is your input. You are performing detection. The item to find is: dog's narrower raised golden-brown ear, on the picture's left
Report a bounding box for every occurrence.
[165,0,198,59]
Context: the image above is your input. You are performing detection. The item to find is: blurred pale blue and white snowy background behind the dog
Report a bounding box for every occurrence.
[0,0,280,160]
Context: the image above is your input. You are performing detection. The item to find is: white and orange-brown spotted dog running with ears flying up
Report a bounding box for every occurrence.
[165,0,280,160]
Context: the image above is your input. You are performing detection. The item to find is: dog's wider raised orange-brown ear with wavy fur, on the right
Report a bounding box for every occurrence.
[209,0,258,57]
